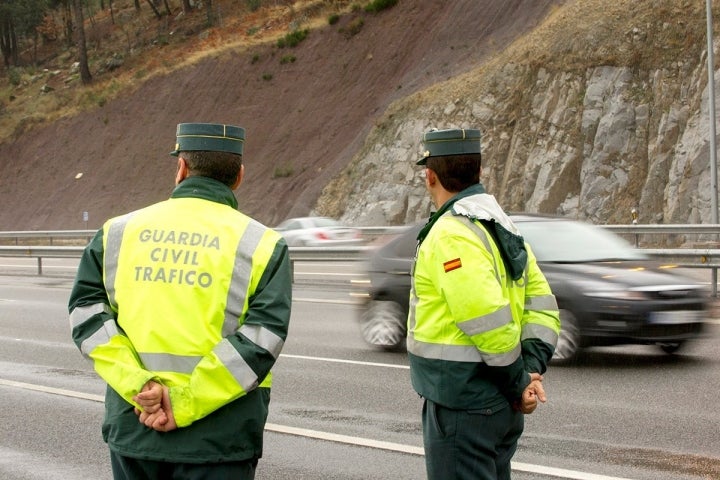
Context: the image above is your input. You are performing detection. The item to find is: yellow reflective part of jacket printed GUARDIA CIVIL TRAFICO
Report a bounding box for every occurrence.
[95,198,283,426]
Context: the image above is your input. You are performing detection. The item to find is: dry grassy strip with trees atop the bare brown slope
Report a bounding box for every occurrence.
[0,0,397,142]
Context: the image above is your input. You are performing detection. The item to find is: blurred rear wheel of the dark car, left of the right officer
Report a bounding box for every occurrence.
[360,300,407,350]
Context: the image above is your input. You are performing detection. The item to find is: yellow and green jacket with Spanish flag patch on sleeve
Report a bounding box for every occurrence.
[408,184,560,411]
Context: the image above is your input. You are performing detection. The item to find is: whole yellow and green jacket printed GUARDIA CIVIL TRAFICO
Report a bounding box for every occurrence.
[69,177,292,463]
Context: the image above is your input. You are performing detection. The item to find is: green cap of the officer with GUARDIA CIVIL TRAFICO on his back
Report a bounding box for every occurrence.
[170,123,245,157]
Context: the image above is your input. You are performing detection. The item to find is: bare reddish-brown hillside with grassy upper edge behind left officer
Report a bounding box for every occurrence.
[0,0,562,230]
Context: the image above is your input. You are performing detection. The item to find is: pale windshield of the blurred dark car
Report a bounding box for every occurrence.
[516,220,646,263]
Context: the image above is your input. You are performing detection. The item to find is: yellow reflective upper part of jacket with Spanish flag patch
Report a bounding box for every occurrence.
[408,213,560,366]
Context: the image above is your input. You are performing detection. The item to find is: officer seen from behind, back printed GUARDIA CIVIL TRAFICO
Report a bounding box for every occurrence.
[69,123,292,480]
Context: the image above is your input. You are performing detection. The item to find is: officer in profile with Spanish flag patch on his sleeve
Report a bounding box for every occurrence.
[407,129,560,480]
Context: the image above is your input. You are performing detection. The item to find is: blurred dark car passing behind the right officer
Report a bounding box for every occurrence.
[356,214,710,361]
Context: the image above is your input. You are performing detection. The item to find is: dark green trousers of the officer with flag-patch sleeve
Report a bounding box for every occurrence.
[422,399,525,480]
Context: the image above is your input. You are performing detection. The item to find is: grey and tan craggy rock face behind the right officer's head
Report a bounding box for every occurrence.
[315,1,718,229]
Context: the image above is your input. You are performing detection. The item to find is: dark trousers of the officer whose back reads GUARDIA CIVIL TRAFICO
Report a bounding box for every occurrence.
[110,451,258,480]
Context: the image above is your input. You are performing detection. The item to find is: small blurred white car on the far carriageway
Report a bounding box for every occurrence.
[275,217,363,247]
